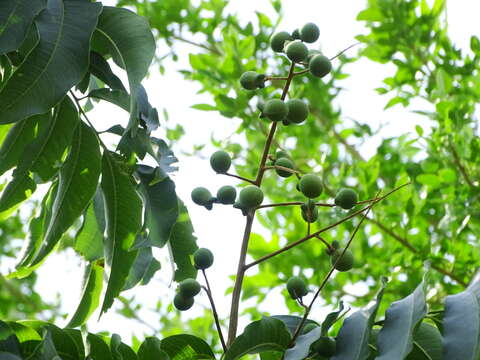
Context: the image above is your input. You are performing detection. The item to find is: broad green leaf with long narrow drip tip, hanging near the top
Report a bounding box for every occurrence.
[93,6,155,136]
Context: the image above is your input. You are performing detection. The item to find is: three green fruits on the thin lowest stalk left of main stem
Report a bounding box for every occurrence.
[173,248,213,311]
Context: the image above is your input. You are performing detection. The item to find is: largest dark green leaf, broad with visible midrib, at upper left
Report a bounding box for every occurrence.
[0,0,102,124]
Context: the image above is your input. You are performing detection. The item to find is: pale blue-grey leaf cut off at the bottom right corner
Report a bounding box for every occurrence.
[443,272,480,360]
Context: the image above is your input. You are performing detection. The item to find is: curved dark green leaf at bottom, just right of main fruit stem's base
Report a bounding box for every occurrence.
[224,317,291,360]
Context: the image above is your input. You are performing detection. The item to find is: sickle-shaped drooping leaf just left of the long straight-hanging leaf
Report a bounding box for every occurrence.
[31,122,101,266]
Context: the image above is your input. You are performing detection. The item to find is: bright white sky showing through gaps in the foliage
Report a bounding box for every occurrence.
[10,0,480,343]
